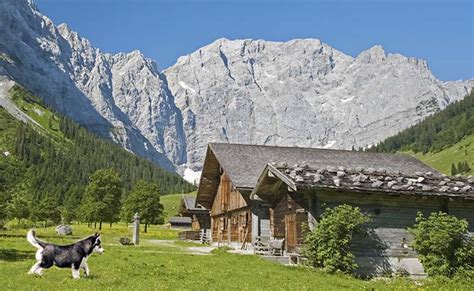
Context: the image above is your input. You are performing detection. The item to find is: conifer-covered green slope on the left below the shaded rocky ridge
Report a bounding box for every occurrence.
[0,86,194,225]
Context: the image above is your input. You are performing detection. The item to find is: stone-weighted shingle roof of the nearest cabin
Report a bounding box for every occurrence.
[253,164,474,199]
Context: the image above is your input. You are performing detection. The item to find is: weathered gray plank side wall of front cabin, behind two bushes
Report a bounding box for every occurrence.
[312,191,474,275]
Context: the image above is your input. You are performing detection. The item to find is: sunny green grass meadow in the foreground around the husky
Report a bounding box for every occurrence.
[0,224,474,290]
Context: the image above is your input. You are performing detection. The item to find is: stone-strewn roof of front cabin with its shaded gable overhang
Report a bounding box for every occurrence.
[250,164,474,202]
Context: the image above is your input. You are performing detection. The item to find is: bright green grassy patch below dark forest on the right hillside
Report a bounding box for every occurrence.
[413,134,474,175]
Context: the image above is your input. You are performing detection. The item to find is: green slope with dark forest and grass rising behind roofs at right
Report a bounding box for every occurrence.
[367,90,474,175]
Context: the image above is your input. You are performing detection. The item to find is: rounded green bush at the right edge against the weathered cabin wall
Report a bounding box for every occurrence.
[409,212,474,277]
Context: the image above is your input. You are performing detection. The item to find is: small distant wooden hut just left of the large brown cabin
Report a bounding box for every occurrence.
[179,195,211,230]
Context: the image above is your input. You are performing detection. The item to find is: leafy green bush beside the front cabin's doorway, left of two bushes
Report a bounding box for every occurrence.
[303,204,370,274]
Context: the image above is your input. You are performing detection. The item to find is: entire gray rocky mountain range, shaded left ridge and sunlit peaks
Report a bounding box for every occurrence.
[0,0,474,182]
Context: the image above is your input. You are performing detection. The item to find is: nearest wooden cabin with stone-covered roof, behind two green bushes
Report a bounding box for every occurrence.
[251,164,474,276]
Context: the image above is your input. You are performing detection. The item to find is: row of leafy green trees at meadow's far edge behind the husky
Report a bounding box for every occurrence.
[5,169,164,232]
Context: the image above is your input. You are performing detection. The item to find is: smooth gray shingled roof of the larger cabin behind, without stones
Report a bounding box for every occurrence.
[209,143,439,188]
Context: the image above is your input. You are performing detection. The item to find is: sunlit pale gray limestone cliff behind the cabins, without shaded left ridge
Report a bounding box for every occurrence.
[165,39,474,168]
